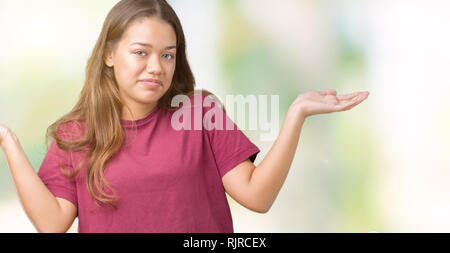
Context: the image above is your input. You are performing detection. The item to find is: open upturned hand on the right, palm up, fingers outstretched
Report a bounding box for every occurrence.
[291,90,369,117]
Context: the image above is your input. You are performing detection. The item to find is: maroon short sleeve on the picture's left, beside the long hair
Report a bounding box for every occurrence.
[38,140,78,208]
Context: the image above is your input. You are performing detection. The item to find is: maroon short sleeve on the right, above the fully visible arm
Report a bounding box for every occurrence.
[203,96,260,177]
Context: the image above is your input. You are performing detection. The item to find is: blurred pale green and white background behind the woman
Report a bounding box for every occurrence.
[0,0,450,233]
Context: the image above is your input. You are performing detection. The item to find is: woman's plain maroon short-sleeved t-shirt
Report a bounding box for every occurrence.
[38,94,260,233]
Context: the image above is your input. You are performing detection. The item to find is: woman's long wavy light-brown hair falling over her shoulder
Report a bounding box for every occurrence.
[46,0,216,208]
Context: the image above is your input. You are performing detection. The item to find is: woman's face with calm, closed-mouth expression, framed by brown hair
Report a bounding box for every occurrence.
[105,17,177,116]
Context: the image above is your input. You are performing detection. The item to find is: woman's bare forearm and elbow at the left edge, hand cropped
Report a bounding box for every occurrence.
[0,124,77,233]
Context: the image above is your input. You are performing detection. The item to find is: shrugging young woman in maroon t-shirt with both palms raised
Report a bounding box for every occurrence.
[0,0,369,232]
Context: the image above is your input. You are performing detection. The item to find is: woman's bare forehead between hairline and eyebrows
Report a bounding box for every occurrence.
[121,17,177,48]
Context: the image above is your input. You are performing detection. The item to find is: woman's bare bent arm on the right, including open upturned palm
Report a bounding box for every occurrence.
[222,90,369,213]
